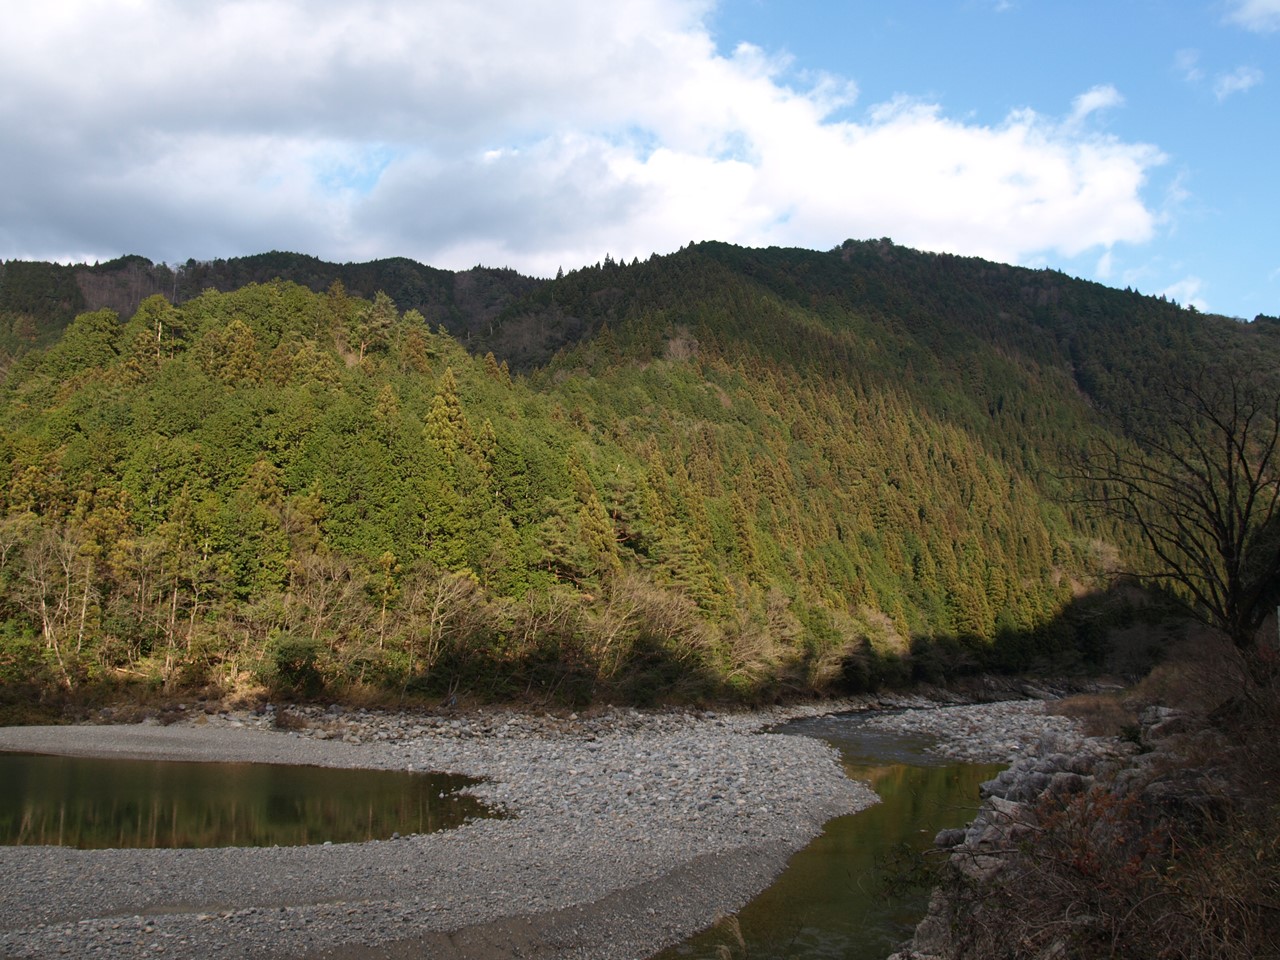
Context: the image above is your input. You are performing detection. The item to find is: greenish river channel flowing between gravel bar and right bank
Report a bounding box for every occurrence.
[654,718,1001,960]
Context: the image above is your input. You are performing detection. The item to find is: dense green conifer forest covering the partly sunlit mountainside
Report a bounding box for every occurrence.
[0,241,1280,703]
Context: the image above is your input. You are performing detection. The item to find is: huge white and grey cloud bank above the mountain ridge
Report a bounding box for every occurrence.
[0,0,1164,273]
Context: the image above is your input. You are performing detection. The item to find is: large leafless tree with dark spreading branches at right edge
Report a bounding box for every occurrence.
[1075,369,1280,652]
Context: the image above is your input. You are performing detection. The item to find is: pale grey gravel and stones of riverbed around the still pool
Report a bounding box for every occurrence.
[0,698,1085,960]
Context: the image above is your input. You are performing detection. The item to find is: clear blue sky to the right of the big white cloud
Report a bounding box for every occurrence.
[712,0,1280,319]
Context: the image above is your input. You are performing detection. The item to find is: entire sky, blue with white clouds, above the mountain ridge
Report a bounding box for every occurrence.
[0,0,1280,319]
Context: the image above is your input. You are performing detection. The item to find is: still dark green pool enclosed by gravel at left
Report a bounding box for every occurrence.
[0,753,490,850]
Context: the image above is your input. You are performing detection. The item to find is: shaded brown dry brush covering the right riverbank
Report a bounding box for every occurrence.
[940,634,1280,960]
